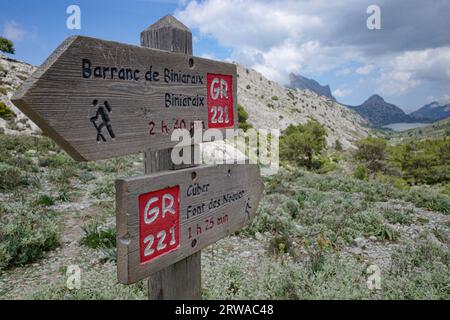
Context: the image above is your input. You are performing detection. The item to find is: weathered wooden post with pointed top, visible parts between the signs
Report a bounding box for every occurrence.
[141,15,201,300]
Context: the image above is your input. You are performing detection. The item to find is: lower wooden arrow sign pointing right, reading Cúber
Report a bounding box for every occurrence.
[116,164,264,284]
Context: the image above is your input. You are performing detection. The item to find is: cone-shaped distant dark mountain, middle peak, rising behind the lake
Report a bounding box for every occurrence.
[348,95,411,127]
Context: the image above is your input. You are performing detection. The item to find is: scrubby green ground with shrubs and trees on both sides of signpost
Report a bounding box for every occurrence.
[0,101,450,299]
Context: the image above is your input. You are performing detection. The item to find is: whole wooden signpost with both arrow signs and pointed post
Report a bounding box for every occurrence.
[12,16,264,299]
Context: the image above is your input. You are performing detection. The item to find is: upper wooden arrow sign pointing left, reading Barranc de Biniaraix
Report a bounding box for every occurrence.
[12,36,237,161]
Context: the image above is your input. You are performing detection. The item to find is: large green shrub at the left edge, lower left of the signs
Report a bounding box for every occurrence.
[0,203,59,270]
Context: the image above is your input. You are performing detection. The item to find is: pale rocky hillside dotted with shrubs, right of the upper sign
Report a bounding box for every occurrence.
[237,65,370,149]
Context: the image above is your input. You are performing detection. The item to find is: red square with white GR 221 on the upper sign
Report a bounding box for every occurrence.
[207,73,234,128]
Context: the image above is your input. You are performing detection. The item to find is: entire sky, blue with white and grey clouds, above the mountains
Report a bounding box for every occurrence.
[0,0,450,112]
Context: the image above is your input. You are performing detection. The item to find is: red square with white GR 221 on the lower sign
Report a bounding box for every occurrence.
[139,186,180,264]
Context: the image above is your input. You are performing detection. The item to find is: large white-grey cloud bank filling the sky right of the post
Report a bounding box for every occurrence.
[175,0,450,96]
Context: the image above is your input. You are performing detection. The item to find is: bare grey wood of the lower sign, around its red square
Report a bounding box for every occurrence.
[116,164,264,284]
